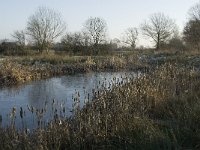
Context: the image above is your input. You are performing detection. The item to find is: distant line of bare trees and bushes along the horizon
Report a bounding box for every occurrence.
[0,2,200,55]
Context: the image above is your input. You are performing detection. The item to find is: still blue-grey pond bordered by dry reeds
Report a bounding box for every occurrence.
[0,72,140,130]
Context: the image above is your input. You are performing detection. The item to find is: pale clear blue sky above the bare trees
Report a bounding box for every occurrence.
[0,0,199,44]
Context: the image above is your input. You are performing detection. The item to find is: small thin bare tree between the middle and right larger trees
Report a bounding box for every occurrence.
[123,28,138,49]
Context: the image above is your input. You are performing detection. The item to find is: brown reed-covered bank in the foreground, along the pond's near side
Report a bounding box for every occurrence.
[0,63,200,150]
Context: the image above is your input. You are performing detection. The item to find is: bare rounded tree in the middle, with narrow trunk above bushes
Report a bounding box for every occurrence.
[84,17,107,46]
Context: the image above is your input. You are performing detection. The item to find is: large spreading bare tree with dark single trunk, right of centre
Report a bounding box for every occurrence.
[141,13,177,49]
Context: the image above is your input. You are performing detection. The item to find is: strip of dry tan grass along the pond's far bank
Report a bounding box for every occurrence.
[0,54,144,86]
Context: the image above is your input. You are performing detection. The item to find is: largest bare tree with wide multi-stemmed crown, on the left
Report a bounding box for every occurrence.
[27,7,66,52]
